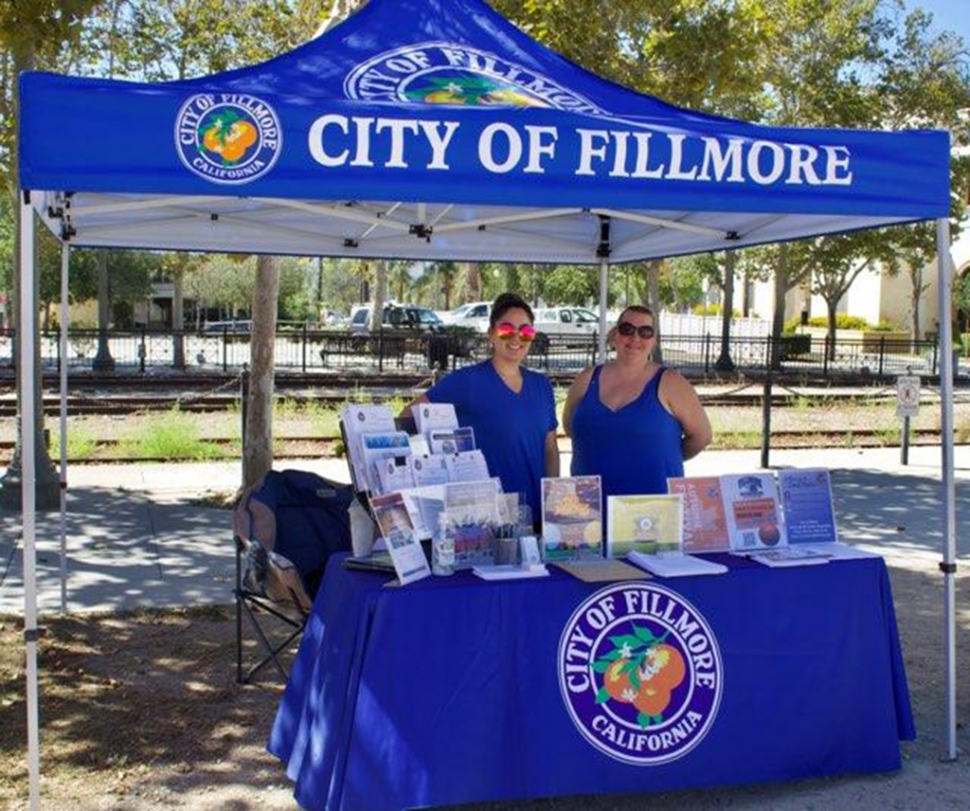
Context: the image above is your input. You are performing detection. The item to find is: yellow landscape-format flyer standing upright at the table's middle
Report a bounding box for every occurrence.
[606,494,682,558]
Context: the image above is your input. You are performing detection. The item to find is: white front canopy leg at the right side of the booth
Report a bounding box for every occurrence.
[936,217,957,761]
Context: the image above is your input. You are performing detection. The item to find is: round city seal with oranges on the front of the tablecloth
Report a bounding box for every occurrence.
[558,583,724,766]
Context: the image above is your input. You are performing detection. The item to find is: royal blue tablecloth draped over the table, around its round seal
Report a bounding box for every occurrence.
[269,556,915,811]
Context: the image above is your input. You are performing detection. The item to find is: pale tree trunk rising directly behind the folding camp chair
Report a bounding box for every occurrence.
[243,256,281,488]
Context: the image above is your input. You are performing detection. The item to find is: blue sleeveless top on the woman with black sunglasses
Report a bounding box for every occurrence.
[572,366,684,498]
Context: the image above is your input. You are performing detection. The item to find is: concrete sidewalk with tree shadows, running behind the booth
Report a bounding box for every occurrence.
[0,446,970,614]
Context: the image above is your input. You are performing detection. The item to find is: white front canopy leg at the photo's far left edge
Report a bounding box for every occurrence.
[17,190,40,811]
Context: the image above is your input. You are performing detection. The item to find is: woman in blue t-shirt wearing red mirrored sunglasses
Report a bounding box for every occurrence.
[406,293,559,518]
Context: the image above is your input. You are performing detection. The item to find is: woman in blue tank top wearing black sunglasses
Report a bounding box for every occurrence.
[563,305,711,506]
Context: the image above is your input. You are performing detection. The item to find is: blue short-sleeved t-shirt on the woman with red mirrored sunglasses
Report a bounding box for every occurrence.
[427,360,559,520]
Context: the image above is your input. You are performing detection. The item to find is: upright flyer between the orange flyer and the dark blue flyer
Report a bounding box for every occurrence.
[721,473,788,552]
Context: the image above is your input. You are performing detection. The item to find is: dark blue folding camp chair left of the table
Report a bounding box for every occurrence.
[233,470,354,684]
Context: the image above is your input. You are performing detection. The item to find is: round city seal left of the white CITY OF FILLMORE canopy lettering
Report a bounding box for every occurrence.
[175,93,283,184]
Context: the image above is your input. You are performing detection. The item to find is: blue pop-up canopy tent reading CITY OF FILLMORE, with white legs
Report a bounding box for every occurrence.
[13,0,956,804]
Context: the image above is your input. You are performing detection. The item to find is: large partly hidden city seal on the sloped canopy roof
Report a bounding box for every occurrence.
[344,42,602,113]
